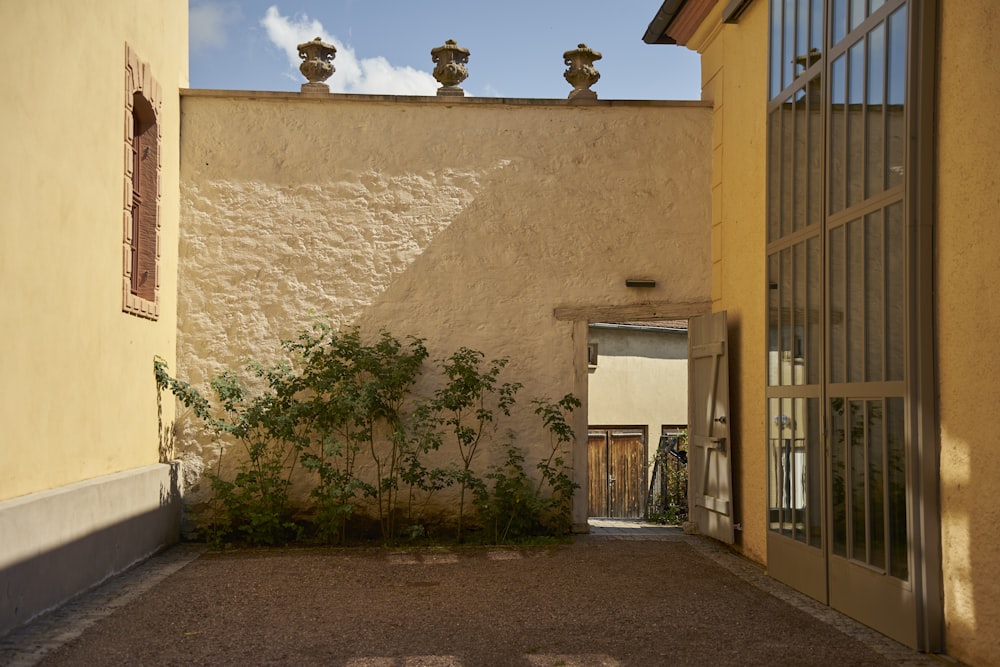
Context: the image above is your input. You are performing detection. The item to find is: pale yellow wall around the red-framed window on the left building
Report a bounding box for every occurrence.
[0,0,188,500]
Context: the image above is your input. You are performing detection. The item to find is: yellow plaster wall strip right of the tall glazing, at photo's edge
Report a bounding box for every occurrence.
[934,0,1000,665]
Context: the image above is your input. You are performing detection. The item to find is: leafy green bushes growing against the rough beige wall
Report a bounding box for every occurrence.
[154,324,580,545]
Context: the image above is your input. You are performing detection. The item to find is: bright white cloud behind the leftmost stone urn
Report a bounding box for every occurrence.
[260,5,438,95]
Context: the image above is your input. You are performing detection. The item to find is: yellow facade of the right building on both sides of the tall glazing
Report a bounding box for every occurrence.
[687,0,1000,665]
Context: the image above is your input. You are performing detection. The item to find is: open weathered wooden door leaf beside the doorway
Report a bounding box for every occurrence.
[688,311,733,544]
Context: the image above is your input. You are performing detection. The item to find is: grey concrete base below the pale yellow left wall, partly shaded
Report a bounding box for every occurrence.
[0,463,181,636]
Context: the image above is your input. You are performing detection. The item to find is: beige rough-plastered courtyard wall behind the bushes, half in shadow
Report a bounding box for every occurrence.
[176,91,711,518]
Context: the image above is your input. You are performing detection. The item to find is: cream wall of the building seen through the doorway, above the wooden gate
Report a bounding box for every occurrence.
[588,327,687,461]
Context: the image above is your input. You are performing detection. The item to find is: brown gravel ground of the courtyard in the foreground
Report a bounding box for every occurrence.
[0,534,935,667]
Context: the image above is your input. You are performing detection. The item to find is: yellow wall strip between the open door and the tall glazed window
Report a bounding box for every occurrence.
[688,2,768,562]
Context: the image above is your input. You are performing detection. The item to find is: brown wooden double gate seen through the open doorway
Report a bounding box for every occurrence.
[587,428,646,519]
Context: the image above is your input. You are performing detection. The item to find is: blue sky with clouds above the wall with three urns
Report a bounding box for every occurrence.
[190,0,700,100]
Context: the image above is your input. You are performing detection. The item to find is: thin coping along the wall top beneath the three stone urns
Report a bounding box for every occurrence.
[180,88,712,109]
